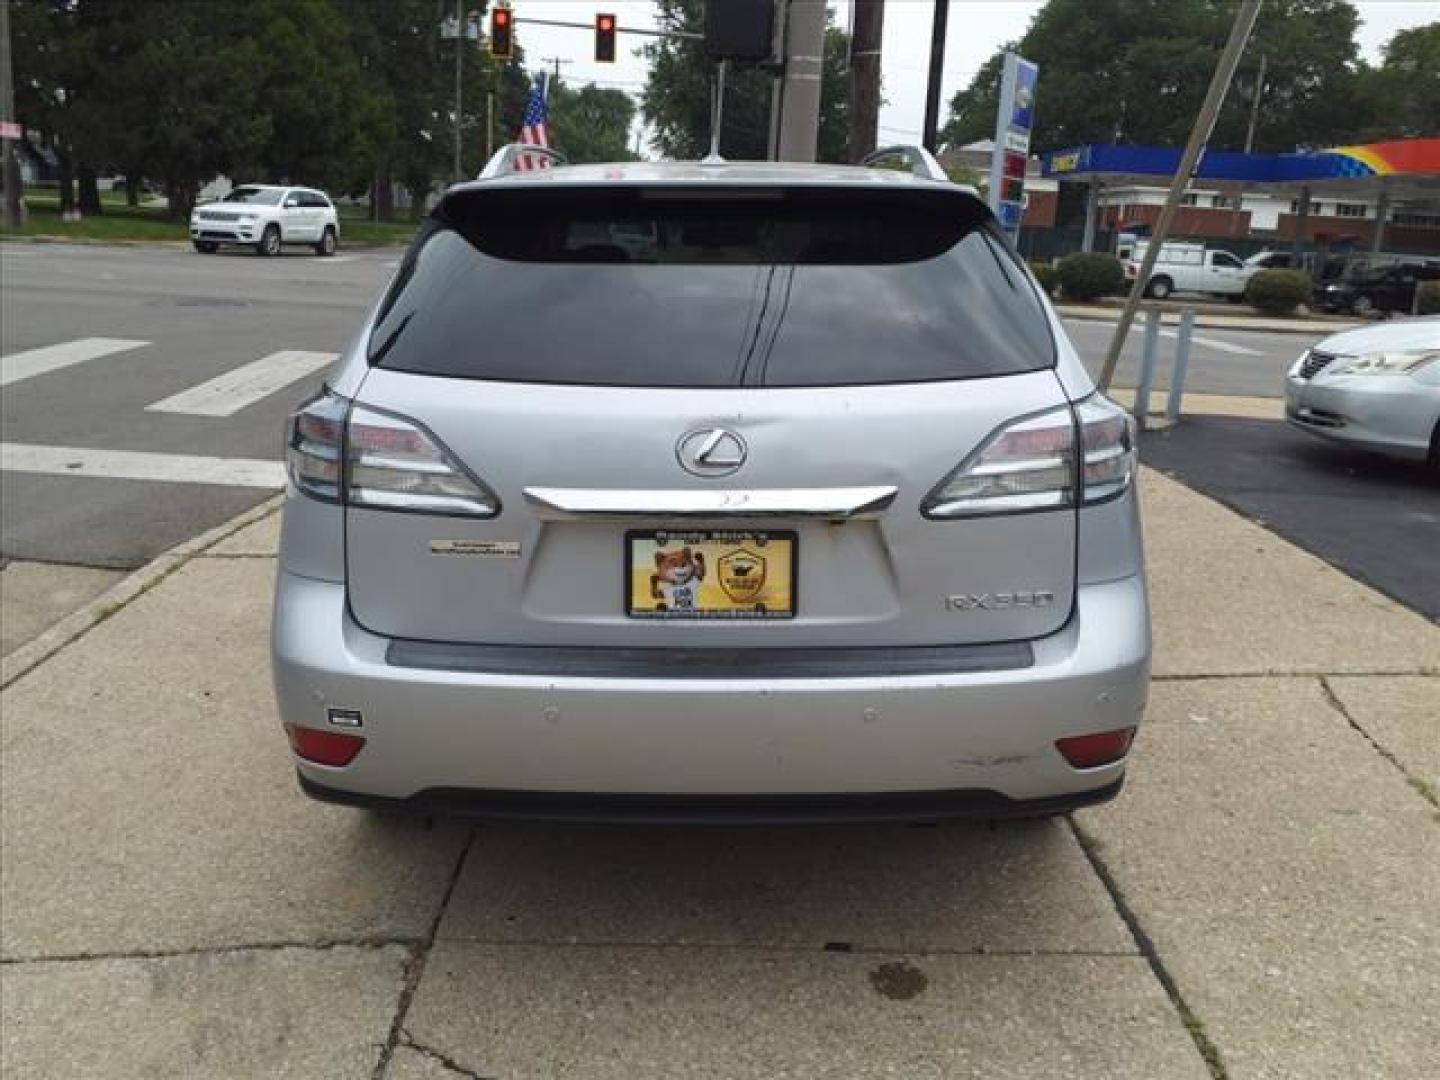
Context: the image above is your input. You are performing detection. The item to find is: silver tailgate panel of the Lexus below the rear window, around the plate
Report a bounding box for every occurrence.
[347,372,1076,647]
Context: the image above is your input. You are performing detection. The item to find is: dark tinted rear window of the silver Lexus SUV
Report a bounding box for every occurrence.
[370,187,1054,387]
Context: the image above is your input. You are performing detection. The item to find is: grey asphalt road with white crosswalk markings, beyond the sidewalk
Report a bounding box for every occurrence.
[0,243,1382,601]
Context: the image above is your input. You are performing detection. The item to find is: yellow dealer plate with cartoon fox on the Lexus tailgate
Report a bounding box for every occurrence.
[625,528,799,619]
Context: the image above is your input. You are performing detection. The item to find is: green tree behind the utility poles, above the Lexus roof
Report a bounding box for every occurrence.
[641,0,850,161]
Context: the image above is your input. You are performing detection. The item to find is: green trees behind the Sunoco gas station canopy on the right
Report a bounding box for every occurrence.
[942,0,1411,151]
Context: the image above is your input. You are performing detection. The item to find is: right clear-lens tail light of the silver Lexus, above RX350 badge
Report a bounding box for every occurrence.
[920,395,1135,518]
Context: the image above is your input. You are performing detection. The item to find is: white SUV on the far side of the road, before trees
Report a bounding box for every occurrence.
[190,184,340,255]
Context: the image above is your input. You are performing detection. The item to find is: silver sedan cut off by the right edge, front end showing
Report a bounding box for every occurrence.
[1284,318,1440,468]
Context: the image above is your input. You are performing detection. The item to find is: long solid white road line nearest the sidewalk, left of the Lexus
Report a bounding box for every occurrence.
[0,442,285,488]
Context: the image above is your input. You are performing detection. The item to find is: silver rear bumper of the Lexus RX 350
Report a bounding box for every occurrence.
[272,572,1151,821]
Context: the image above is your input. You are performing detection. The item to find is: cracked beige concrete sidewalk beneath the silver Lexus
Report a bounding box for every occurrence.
[0,472,1440,1080]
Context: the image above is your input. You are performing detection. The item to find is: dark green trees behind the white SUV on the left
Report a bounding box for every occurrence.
[10,0,590,216]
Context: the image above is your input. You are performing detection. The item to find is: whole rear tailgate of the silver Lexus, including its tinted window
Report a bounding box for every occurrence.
[347,184,1076,647]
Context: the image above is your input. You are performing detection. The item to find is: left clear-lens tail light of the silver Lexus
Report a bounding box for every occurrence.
[285,390,500,517]
